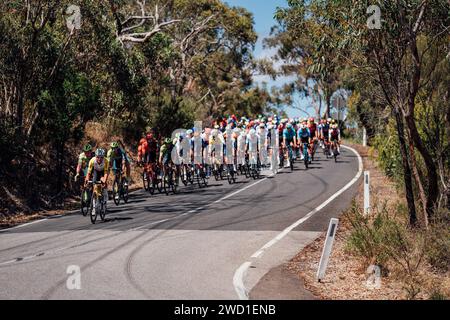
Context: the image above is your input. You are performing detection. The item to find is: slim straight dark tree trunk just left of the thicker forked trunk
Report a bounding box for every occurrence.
[394,109,417,226]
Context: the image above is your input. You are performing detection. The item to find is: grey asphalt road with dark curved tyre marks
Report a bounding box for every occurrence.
[0,148,359,299]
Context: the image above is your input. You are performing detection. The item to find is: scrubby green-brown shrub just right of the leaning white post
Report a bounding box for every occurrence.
[346,201,427,299]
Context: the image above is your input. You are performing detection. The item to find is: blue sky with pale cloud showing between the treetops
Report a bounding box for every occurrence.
[224,0,308,117]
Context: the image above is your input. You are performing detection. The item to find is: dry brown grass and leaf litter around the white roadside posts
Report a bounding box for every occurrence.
[285,145,450,300]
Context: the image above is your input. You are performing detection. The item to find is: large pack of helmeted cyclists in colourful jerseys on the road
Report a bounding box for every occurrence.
[75,115,341,210]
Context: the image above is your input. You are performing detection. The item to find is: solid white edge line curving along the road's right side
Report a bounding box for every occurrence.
[233,146,363,300]
